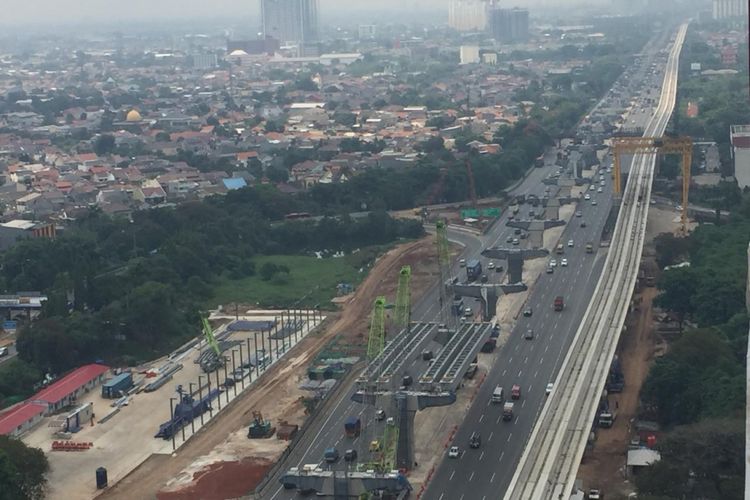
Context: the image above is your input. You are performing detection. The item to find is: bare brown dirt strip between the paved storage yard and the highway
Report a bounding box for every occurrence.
[100,237,435,500]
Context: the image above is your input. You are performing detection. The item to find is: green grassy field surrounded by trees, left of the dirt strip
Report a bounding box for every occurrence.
[209,247,386,309]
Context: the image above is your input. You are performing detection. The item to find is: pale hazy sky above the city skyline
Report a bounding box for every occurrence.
[0,0,588,24]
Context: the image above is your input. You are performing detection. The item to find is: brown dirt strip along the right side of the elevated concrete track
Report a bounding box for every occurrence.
[578,207,679,499]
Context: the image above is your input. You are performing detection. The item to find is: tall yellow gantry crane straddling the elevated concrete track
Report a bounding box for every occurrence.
[612,136,693,234]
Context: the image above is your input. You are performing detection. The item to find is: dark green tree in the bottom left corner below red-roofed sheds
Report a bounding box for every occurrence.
[0,436,49,500]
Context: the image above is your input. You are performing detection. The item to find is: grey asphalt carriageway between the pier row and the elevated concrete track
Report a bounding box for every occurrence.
[423,33,676,500]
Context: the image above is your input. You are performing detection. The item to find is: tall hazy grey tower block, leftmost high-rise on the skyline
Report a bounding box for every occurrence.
[260,0,320,44]
